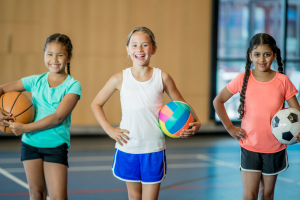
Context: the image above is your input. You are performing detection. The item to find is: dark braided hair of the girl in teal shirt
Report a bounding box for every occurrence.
[44,33,73,75]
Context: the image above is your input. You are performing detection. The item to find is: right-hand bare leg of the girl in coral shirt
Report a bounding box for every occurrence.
[259,175,277,200]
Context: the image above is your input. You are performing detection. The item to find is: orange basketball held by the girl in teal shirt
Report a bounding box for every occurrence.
[0,92,35,133]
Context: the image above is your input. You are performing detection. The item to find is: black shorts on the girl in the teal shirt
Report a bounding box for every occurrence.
[21,142,69,167]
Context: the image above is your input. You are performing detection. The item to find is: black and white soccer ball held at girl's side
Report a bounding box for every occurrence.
[271,108,300,144]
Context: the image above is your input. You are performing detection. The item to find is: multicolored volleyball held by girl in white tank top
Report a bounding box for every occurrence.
[158,101,195,138]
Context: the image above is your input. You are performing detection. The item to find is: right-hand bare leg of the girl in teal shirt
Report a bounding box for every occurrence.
[44,162,68,200]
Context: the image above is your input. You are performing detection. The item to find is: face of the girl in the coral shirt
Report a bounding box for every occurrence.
[249,45,276,72]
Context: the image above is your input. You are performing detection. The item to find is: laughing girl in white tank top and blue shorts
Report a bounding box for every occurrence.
[91,27,201,200]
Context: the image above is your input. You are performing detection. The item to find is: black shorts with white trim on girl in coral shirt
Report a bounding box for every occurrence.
[240,147,289,176]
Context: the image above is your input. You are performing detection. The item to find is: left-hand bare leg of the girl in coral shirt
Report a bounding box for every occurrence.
[241,170,261,200]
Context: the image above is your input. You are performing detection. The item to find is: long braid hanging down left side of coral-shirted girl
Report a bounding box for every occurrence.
[238,48,252,119]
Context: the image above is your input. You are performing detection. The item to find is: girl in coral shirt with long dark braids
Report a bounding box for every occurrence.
[214,33,300,200]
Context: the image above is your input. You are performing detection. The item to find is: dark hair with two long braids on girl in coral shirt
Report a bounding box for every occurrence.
[238,33,283,119]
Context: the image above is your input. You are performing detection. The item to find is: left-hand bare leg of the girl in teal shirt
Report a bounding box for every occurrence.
[23,159,47,200]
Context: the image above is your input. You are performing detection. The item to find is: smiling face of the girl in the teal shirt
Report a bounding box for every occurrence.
[44,42,71,74]
